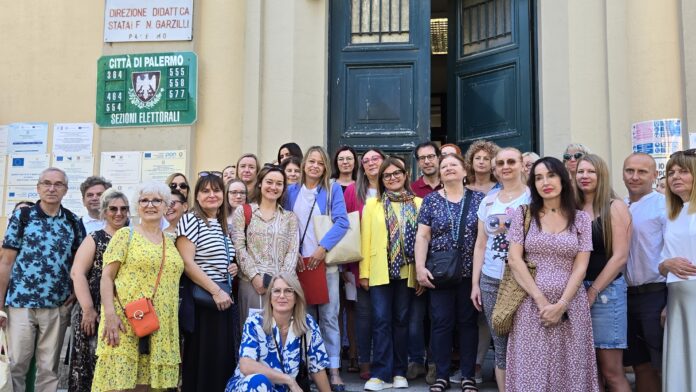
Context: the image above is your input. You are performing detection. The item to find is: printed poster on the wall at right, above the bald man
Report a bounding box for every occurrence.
[631,118,682,178]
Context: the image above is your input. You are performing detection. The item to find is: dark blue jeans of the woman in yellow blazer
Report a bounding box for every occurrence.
[370,279,413,382]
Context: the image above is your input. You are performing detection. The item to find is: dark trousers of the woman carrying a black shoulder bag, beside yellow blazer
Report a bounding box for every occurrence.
[430,278,478,379]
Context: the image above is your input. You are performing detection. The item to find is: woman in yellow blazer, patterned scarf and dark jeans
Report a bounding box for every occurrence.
[360,157,422,391]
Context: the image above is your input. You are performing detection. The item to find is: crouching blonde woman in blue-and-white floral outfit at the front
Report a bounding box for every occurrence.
[225,272,331,392]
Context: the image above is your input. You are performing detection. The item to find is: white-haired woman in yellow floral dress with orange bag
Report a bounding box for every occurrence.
[92,182,184,392]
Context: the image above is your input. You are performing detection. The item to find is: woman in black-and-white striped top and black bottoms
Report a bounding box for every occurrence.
[176,172,239,392]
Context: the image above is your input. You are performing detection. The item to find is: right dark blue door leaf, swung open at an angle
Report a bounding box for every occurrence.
[448,0,534,151]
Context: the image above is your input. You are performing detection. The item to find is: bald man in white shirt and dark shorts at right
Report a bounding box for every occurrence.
[623,153,667,392]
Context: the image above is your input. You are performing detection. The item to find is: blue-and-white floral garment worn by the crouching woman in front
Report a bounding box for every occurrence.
[225,313,329,391]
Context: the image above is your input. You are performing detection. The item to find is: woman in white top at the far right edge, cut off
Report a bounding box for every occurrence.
[658,148,696,391]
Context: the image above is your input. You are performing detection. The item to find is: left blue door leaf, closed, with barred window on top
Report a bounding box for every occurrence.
[328,0,430,159]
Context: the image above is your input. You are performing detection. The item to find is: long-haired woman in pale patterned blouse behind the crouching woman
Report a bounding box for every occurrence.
[232,165,300,325]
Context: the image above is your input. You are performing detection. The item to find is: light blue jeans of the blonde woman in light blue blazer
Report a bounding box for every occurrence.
[307,271,341,369]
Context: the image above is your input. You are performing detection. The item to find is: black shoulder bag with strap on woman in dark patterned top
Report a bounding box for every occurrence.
[425,189,471,289]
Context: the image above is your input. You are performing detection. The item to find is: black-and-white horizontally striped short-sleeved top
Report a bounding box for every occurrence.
[176,212,235,282]
